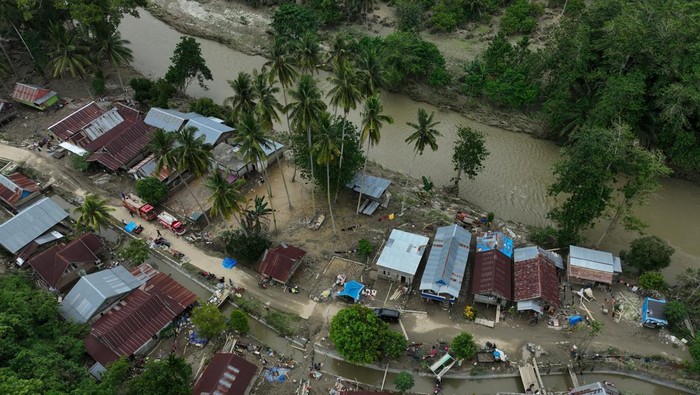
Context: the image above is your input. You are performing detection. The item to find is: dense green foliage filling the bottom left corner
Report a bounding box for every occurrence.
[0,273,92,394]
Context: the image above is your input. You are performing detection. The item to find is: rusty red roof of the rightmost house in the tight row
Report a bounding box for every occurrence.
[513,254,559,306]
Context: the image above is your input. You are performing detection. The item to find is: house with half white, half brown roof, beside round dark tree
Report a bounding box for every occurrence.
[566,246,622,284]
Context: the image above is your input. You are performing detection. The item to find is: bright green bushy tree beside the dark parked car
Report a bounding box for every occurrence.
[330,305,406,364]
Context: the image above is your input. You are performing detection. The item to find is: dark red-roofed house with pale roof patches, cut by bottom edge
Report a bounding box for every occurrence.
[192,352,258,395]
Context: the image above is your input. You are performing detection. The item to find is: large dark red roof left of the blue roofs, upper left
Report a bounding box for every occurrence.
[84,104,155,170]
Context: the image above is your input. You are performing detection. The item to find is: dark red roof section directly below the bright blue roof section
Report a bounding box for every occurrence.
[472,250,513,300]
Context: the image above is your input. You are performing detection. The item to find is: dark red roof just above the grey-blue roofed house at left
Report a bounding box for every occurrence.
[28,233,103,288]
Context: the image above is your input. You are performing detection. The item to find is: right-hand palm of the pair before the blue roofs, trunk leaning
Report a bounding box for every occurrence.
[170,126,214,226]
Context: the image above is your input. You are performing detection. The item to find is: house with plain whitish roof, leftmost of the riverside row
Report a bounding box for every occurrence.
[377,229,429,284]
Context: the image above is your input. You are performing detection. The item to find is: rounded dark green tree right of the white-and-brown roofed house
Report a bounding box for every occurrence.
[620,236,676,273]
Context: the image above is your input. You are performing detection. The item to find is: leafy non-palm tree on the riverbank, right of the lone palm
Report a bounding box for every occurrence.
[452,126,489,194]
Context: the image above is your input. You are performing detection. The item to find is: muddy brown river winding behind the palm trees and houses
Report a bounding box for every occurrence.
[120,11,700,281]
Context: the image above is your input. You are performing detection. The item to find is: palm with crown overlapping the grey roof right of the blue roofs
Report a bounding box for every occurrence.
[233,112,277,231]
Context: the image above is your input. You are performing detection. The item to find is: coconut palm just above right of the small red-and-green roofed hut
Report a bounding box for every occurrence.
[49,24,93,98]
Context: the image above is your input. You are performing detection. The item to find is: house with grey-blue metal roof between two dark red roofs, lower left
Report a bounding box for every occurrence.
[59,266,144,324]
